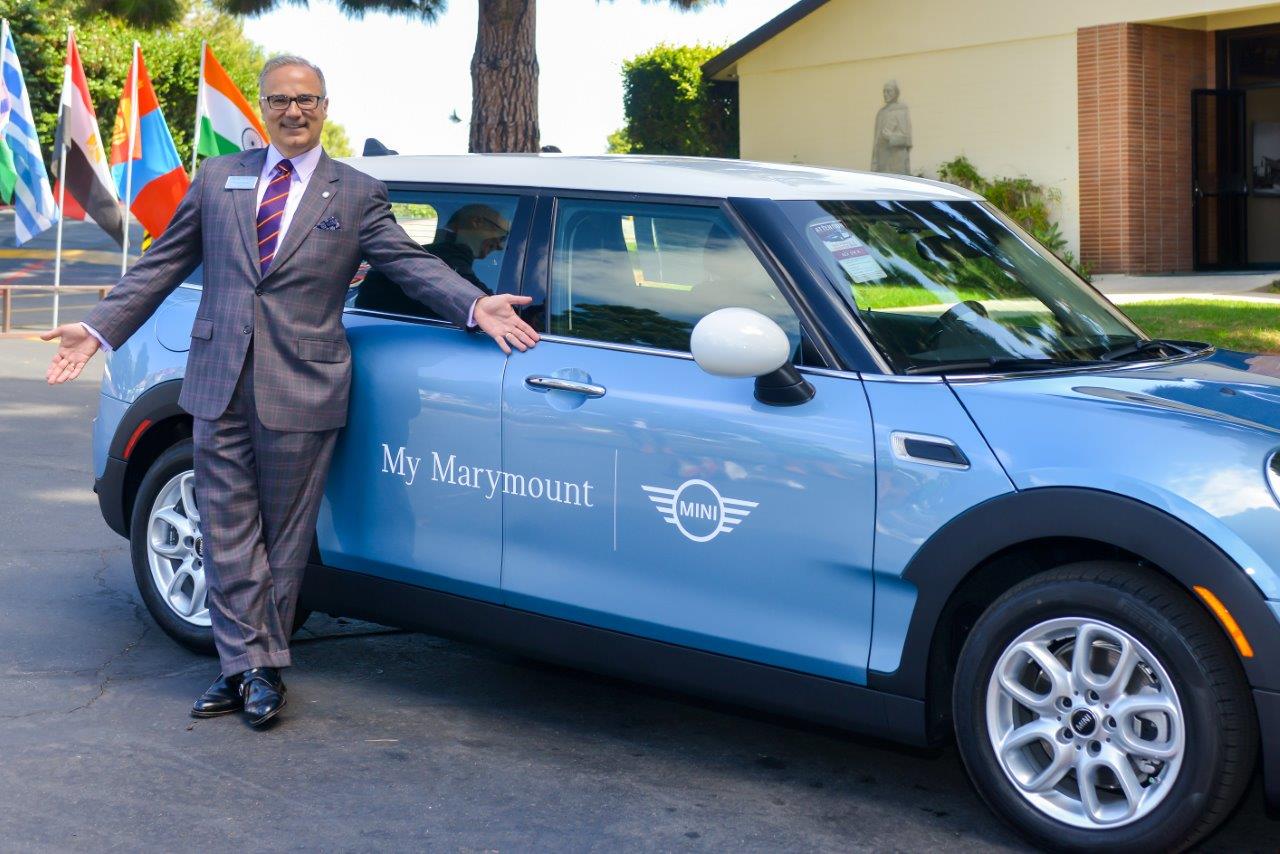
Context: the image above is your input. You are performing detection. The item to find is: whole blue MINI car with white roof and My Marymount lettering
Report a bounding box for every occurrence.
[93,155,1280,850]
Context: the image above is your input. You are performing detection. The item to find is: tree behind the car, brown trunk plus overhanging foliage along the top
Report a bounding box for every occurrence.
[107,0,723,151]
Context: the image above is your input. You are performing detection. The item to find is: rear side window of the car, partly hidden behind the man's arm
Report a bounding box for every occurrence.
[348,191,518,319]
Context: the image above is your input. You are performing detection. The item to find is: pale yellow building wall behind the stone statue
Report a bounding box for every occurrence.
[736,0,1280,261]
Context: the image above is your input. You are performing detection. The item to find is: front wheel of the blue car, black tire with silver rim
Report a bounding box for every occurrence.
[952,561,1258,851]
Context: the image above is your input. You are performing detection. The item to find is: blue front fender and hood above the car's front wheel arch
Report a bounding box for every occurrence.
[952,359,1280,600]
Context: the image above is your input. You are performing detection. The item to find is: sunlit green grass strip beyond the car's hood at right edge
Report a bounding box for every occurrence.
[1120,300,1280,353]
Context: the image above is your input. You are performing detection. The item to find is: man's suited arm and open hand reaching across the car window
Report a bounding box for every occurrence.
[360,182,538,353]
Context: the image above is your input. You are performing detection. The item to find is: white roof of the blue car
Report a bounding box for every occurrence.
[343,154,979,201]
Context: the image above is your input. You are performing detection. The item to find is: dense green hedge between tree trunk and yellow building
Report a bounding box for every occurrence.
[609,44,739,157]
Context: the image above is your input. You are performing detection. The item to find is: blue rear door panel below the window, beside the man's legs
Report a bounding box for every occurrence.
[316,312,506,600]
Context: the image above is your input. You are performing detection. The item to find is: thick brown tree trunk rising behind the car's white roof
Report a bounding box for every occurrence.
[467,0,538,152]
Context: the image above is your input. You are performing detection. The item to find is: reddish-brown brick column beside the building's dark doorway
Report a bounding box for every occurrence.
[1076,24,1211,273]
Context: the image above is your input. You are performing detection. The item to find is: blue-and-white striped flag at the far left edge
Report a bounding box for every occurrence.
[0,20,58,246]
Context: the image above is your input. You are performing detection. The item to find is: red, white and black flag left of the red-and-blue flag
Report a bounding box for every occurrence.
[52,32,124,246]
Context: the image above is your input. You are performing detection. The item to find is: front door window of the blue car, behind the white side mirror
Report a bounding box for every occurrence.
[548,200,801,355]
